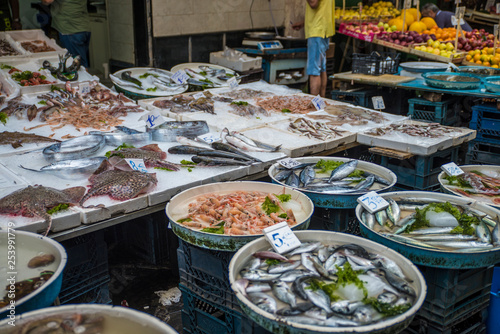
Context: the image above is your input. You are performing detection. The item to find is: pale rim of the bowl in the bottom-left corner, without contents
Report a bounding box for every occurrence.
[0,304,177,334]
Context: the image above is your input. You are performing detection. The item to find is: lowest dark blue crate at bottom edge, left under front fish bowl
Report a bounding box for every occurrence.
[179,284,269,334]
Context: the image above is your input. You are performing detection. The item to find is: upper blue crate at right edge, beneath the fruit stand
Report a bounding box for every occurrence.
[469,104,500,145]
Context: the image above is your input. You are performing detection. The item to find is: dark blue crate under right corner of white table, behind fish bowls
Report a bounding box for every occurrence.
[380,147,459,190]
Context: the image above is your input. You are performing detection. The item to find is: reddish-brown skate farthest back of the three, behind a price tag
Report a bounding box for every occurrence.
[109,144,179,171]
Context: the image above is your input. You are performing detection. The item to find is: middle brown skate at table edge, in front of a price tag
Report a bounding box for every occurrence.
[80,161,158,208]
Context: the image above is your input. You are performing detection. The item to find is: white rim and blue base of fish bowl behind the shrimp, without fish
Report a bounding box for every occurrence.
[268,157,397,209]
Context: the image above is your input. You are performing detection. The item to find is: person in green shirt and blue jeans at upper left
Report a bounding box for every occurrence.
[42,0,90,67]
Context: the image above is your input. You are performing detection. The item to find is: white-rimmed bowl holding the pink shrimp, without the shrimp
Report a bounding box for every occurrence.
[165,181,314,252]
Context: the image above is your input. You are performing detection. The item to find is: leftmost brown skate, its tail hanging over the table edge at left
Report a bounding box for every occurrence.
[0,185,85,235]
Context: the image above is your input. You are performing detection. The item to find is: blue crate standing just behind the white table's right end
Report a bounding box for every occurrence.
[408,98,460,125]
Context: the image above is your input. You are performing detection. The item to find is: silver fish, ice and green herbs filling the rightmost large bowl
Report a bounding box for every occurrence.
[361,199,500,253]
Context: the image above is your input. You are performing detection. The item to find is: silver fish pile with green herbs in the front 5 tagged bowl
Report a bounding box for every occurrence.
[236,242,417,327]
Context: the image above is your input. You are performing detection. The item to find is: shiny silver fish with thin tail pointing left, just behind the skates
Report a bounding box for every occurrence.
[19,157,106,179]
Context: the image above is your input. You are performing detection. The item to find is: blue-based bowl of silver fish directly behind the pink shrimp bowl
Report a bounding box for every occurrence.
[268,157,397,209]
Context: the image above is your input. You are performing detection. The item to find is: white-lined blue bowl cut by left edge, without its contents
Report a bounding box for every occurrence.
[0,230,67,318]
